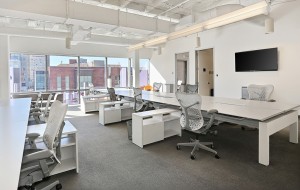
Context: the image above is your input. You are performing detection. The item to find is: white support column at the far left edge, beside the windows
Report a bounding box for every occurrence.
[0,35,10,100]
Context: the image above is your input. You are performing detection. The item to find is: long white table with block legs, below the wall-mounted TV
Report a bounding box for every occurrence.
[116,89,300,166]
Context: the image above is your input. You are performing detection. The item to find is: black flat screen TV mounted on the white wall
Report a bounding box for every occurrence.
[235,48,278,72]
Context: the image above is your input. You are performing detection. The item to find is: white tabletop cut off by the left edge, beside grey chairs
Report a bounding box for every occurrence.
[0,98,31,190]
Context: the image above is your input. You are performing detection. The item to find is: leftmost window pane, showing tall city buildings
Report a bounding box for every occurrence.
[10,53,47,93]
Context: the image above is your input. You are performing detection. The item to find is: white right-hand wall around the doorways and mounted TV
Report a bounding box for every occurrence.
[150,1,300,103]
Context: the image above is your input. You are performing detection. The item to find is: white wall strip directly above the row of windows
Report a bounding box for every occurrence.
[10,36,152,59]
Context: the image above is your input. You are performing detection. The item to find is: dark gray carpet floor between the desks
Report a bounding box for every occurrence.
[51,106,300,190]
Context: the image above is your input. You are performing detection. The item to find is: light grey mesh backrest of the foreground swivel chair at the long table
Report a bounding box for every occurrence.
[176,92,204,131]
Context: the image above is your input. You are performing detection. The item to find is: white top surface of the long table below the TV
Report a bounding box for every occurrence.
[116,89,300,121]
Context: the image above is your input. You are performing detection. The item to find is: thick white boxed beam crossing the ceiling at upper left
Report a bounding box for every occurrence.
[0,0,170,33]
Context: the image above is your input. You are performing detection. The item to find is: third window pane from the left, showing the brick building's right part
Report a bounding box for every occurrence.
[80,57,106,89]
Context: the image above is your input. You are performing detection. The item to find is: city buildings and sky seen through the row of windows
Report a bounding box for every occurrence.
[10,53,149,93]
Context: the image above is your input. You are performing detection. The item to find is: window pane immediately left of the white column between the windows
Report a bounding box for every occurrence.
[107,57,129,87]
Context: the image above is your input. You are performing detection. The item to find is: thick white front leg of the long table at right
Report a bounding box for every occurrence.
[258,122,270,166]
